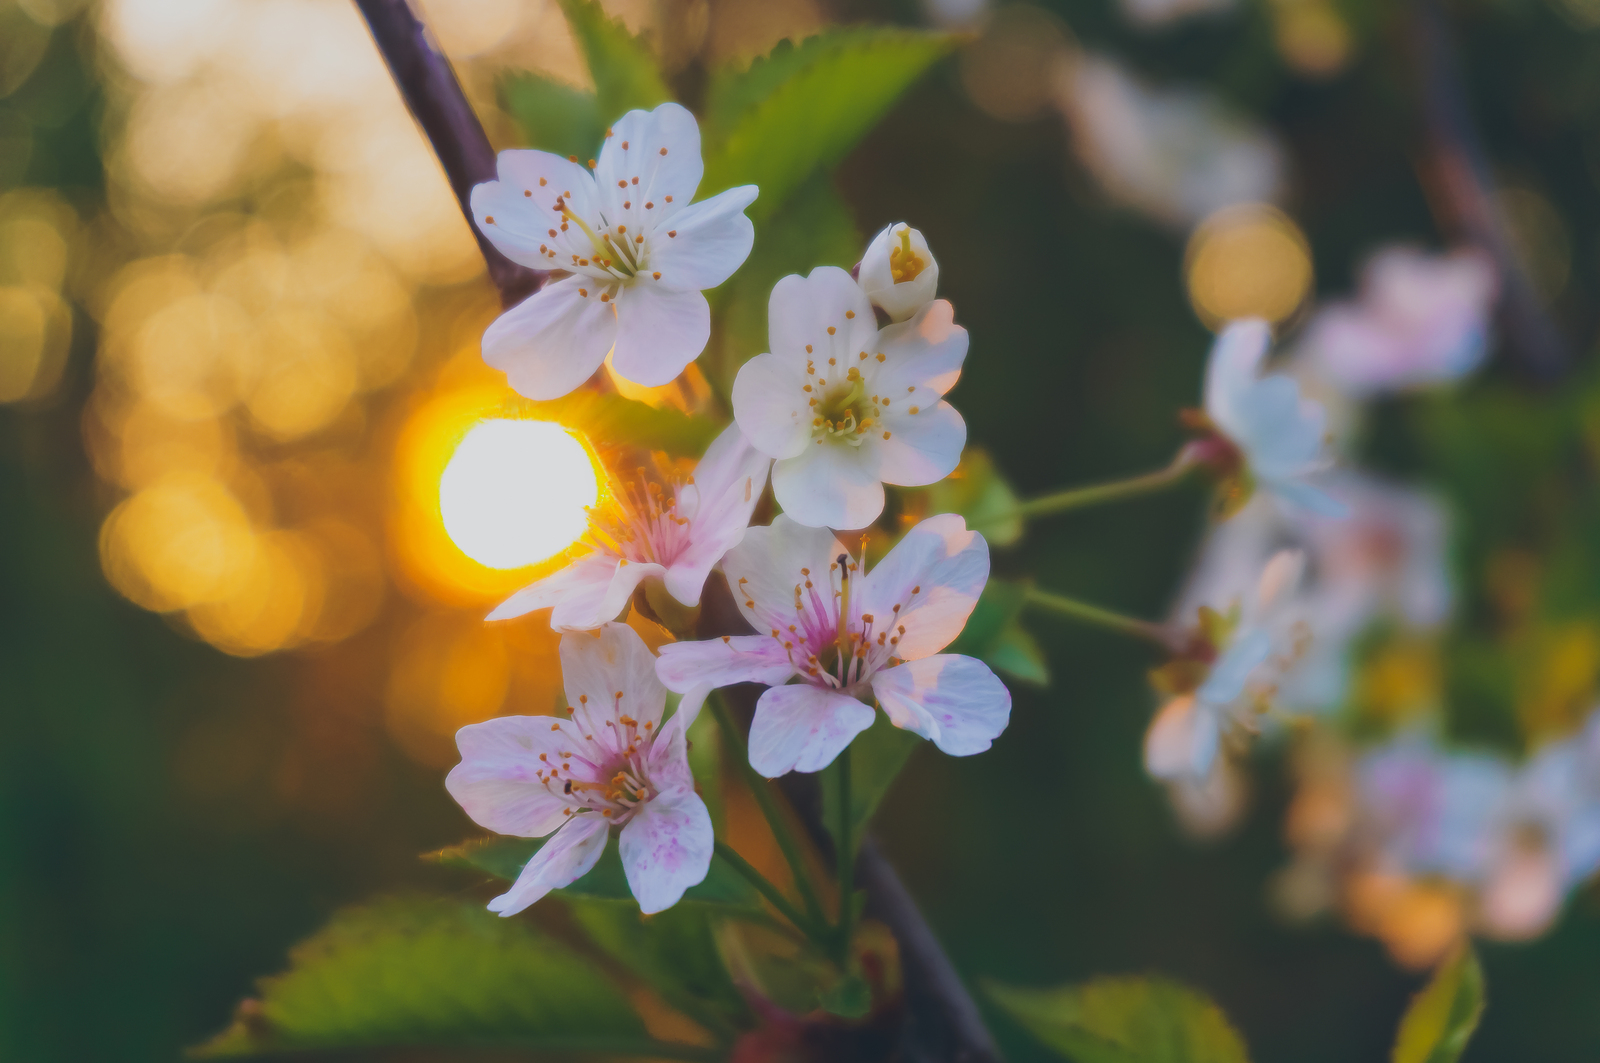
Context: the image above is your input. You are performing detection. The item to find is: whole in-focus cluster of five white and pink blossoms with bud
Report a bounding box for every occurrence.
[446,102,1011,916]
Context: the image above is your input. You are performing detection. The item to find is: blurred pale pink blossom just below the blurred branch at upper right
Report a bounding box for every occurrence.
[1299,247,1499,399]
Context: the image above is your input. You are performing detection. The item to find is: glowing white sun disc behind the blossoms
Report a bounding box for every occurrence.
[438,419,600,568]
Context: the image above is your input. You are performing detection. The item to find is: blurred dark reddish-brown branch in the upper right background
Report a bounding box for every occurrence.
[1410,0,1568,379]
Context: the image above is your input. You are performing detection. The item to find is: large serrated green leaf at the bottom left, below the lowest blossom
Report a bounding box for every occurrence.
[198,898,650,1057]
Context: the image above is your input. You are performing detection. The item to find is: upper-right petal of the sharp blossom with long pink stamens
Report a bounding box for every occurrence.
[861,512,989,661]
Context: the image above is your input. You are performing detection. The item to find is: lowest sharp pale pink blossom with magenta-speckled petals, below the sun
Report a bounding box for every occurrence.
[445,624,712,916]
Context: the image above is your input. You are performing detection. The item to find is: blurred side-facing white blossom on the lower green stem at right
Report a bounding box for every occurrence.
[1144,551,1306,783]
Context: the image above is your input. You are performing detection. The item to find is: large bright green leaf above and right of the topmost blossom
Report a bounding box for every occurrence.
[701,26,957,221]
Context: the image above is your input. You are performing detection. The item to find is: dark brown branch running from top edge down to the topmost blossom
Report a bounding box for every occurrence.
[355,0,547,307]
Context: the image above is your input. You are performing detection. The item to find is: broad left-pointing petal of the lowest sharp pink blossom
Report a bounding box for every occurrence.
[445,716,574,837]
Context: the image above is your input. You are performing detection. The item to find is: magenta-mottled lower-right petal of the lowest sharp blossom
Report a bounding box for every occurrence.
[619,789,714,916]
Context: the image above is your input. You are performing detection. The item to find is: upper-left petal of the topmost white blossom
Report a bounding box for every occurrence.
[472,150,595,269]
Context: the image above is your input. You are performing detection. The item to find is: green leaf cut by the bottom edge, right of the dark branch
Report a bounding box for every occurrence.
[989,978,1248,1063]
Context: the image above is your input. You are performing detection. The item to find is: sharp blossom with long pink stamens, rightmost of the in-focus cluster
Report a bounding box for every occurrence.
[658,514,1011,778]
